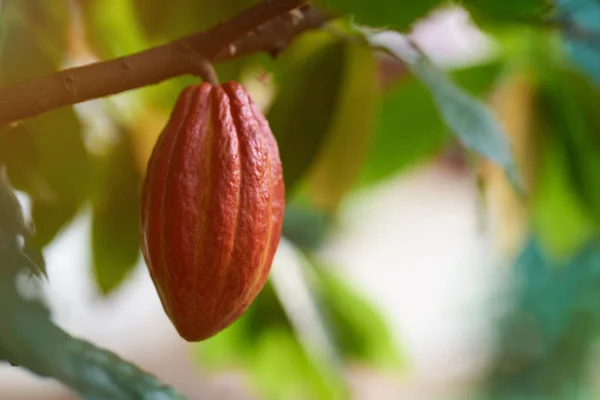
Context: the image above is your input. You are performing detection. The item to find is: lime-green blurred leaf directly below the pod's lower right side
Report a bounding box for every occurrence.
[195,282,342,400]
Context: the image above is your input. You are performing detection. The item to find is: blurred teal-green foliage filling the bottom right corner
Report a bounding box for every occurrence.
[482,237,600,400]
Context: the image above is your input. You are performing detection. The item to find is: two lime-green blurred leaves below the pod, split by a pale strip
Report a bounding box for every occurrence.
[196,255,404,400]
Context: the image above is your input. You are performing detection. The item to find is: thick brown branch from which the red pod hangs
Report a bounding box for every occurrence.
[0,0,326,125]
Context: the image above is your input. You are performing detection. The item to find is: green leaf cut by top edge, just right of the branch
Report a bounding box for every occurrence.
[320,0,440,31]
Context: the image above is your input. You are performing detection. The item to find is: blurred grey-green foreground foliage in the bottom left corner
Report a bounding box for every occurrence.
[0,176,183,400]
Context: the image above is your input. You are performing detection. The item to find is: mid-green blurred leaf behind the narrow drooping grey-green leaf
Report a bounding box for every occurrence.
[361,62,501,184]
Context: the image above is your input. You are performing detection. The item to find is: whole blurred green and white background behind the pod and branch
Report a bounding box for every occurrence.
[0,0,600,400]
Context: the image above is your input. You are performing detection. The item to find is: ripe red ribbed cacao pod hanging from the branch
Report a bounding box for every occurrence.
[141,82,285,341]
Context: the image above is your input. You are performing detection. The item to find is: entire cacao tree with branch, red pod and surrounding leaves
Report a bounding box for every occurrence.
[0,0,600,400]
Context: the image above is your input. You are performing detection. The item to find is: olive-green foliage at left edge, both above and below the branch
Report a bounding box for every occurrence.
[0,0,90,245]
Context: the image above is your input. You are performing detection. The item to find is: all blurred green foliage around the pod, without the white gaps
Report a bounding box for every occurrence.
[0,0,600,399]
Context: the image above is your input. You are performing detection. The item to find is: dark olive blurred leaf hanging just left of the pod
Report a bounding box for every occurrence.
[92,132,142,294]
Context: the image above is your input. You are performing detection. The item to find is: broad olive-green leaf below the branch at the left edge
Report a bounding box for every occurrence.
[0,108,91,246]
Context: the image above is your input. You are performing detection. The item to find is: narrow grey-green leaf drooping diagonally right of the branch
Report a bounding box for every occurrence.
[370,36,524,193]
